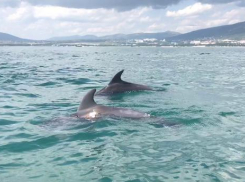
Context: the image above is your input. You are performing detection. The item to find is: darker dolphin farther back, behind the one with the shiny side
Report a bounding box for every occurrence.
[96,70,152,95]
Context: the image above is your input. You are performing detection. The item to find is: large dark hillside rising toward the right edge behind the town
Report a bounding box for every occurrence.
[167,22,245,41]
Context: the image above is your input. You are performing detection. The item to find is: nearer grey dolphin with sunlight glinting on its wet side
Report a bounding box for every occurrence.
[75,89,150,120]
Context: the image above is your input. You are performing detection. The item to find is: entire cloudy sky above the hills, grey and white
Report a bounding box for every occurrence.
[0,0,245,39]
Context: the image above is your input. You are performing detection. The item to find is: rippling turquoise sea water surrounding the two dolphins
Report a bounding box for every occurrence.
[0,47,245,182]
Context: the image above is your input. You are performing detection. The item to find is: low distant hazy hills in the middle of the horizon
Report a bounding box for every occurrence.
[48,31,180,41]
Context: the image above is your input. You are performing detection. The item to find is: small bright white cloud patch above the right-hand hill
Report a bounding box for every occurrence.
[166,3,212,17]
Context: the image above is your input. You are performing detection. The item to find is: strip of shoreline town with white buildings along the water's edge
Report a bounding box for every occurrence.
[0,38,245,47]
